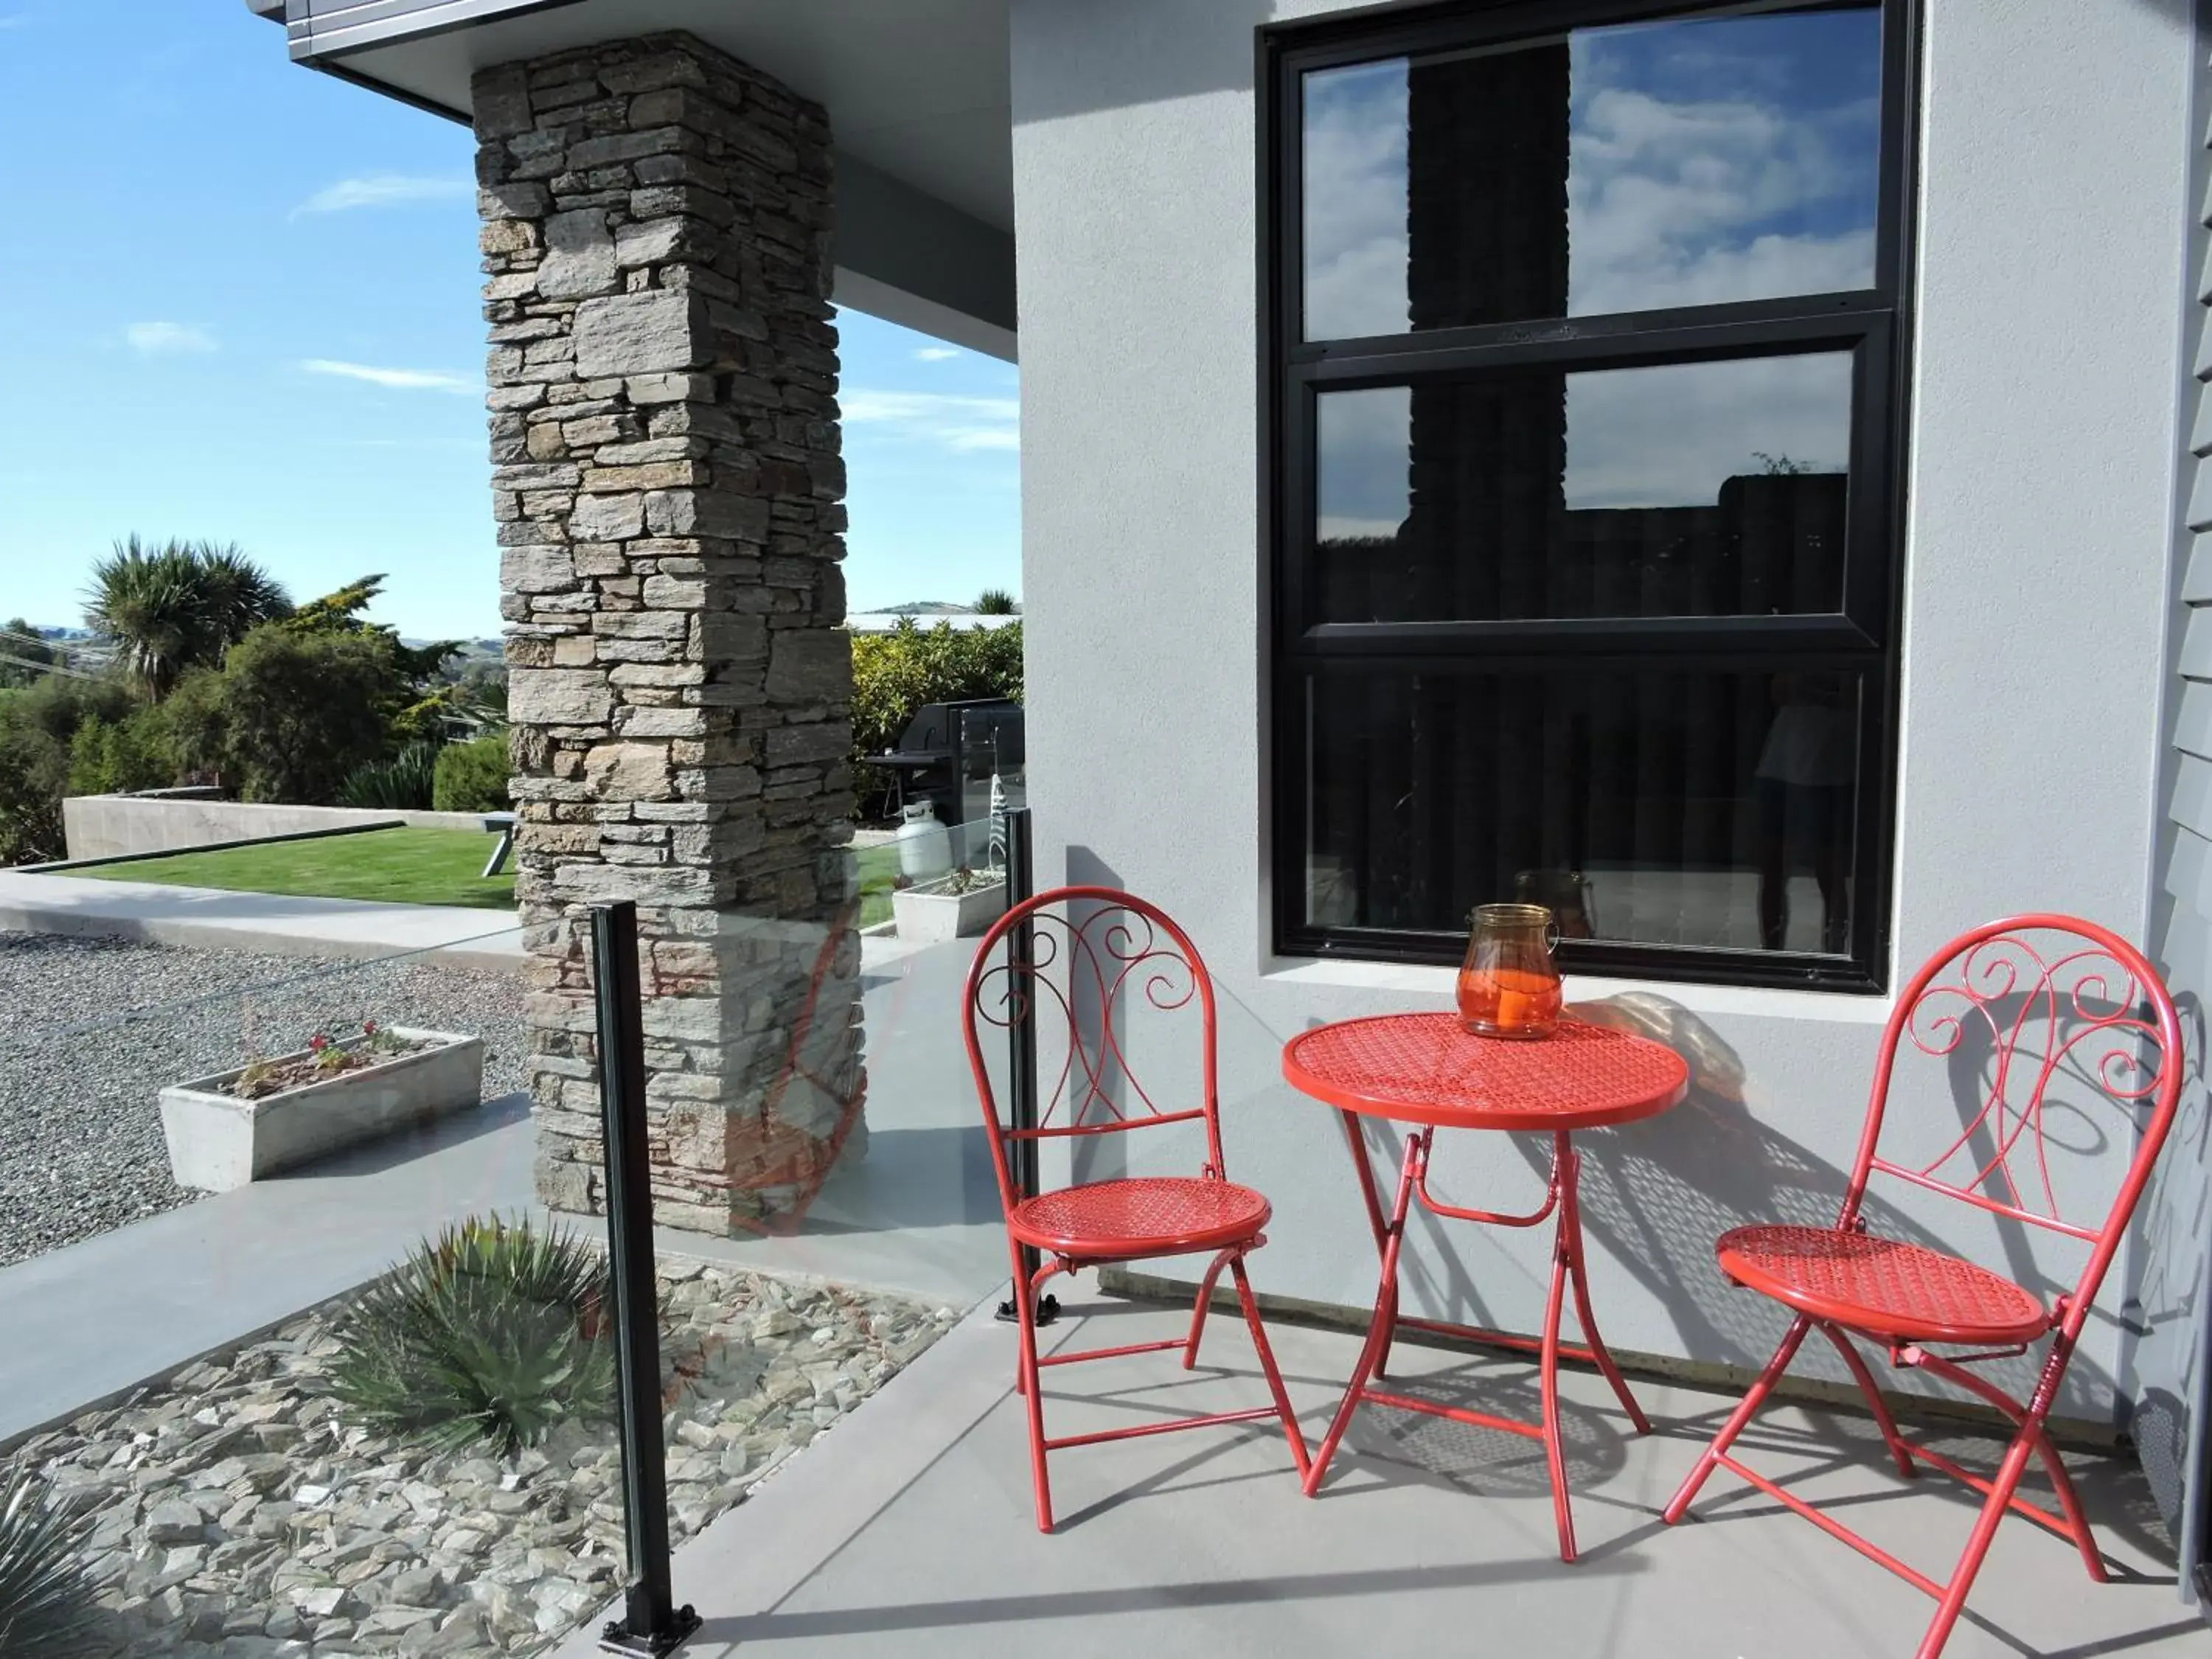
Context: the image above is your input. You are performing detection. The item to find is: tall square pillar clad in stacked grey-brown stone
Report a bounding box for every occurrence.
[473,35,863,1230]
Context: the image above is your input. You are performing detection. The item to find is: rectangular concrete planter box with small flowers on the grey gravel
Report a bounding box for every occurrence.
[161,1026,484,1192]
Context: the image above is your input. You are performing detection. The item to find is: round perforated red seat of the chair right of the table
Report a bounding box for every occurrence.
[1717,1228,2051,1345]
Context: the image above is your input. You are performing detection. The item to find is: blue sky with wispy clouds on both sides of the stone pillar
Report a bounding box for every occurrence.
[0,0,1020,635]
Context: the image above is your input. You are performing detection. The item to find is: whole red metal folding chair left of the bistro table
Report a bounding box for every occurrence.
[960,887,1307,1533]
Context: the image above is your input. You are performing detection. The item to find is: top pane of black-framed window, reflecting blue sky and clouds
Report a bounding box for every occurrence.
[1303,4,1880,341]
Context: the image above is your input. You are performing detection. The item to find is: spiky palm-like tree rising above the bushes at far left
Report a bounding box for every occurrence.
[84,535,292,701]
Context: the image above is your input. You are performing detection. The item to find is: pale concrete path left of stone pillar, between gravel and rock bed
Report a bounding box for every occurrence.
[0,1095,531,1444]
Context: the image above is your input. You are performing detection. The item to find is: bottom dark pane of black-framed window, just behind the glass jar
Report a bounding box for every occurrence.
[1305,666,1863,956]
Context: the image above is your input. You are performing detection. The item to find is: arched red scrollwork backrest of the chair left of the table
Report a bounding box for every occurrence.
[960,887,1221,1210]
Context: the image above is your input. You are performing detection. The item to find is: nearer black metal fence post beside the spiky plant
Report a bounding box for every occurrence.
[591,900,699,1659]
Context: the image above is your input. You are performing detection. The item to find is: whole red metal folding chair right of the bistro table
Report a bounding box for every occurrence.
[1666,916,2183,1659]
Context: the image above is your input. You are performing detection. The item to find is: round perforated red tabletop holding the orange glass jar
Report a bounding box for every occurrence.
[1283,1013,1690,1130]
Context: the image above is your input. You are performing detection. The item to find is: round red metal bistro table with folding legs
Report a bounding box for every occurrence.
[1283,1013,1690,1562]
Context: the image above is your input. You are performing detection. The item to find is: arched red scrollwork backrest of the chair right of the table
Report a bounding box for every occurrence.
[1838,916,2185,1334]
